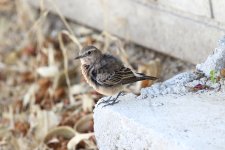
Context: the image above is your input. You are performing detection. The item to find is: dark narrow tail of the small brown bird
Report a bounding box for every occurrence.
[122,73,158,84]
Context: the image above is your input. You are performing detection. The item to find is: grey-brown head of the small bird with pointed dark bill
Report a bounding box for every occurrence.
[75,46,102,65]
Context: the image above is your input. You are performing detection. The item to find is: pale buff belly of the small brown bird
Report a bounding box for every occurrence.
[81,66,123,96]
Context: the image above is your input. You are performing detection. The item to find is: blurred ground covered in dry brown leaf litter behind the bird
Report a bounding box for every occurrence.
[0,0,194,150]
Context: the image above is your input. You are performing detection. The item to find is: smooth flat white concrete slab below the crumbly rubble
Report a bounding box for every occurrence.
[94,94,225,150]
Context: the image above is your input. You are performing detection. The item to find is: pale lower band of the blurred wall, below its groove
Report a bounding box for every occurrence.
[27,0,225,63]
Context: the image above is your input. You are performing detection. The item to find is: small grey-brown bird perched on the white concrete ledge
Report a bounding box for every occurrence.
[75,45,158,107]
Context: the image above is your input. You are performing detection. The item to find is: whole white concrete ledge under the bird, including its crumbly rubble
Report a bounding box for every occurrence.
[94,37,225,150]
